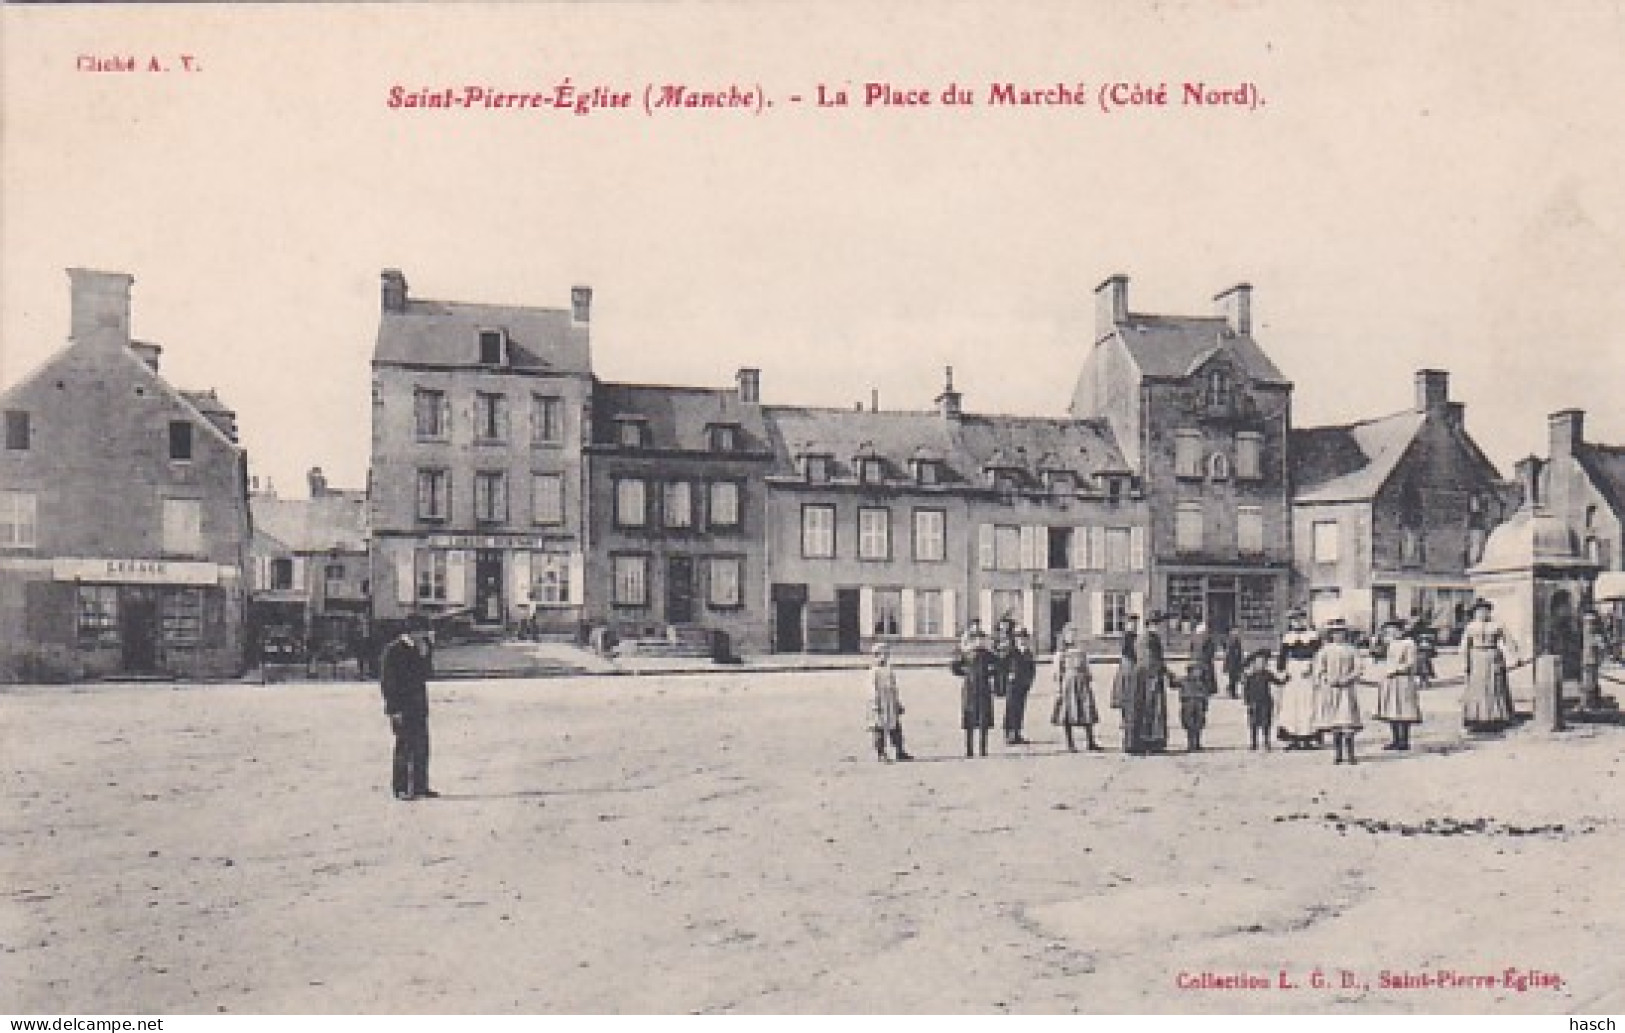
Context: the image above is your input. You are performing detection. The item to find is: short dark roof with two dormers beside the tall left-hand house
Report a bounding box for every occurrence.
[592,382,769,452]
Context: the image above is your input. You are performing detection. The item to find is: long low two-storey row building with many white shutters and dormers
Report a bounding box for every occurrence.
[767,374,1147,655]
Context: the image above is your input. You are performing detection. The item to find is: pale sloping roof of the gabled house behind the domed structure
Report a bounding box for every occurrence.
[1287,409,1427,502]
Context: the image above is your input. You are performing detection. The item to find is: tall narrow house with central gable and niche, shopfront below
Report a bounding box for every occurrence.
[1071,274,1292,642]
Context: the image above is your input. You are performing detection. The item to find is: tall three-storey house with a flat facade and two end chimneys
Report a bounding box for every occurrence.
[369,270,592,635]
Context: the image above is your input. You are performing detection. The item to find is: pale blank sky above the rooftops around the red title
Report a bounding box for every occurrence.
[0,0,1625,494]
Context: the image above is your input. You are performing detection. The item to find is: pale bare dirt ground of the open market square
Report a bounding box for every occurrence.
[0,656,1625,1015]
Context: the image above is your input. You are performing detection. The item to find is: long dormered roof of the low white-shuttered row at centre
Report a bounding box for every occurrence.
[765,406,1131,487]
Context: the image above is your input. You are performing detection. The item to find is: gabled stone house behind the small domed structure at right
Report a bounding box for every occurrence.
[1289,370,1508,642]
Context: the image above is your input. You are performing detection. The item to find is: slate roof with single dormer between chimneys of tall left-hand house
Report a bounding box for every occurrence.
[372,299,592,374]
